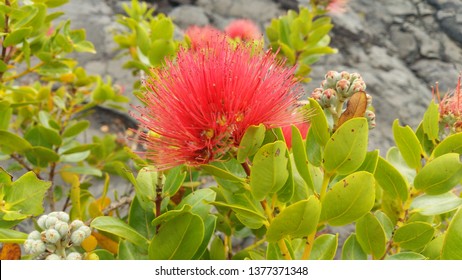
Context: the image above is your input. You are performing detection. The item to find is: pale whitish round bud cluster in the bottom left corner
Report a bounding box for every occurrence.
[24,212,91,260]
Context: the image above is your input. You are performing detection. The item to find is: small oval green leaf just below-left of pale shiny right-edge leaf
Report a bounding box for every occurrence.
[393,222,435,250]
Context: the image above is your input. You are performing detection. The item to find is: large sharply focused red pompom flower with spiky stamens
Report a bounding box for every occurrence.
[135,39,303,169]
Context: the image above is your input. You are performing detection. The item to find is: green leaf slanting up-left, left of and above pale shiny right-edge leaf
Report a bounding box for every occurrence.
[374,157,409,202]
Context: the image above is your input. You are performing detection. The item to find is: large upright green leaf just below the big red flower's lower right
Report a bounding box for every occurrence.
[250,141,289,200]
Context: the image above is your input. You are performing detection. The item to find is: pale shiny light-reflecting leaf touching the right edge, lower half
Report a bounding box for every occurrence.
[411,192,462,216]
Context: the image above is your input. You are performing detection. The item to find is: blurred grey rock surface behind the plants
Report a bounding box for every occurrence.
[62,0,462,155]
